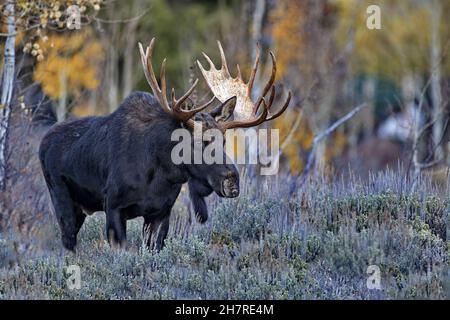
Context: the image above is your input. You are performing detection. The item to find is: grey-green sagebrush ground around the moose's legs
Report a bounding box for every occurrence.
[0,171,450,299]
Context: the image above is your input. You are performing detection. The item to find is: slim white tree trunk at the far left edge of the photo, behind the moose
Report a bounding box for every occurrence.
[0,1,16,190]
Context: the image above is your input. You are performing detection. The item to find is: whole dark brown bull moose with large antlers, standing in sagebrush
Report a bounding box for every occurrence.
[39,38,291,251]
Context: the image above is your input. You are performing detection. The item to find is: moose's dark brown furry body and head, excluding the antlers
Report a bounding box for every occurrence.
[39,92,239,250]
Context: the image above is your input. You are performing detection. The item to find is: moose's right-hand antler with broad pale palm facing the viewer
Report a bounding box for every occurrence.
[197,41,291,130]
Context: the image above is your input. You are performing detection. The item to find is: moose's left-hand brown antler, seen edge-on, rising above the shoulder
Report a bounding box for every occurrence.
[139,38,214,128]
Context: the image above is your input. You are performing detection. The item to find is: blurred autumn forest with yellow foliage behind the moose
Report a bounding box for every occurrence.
[0,0,450,186]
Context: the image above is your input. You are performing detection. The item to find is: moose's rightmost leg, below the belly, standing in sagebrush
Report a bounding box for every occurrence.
[142,212,170,251]
